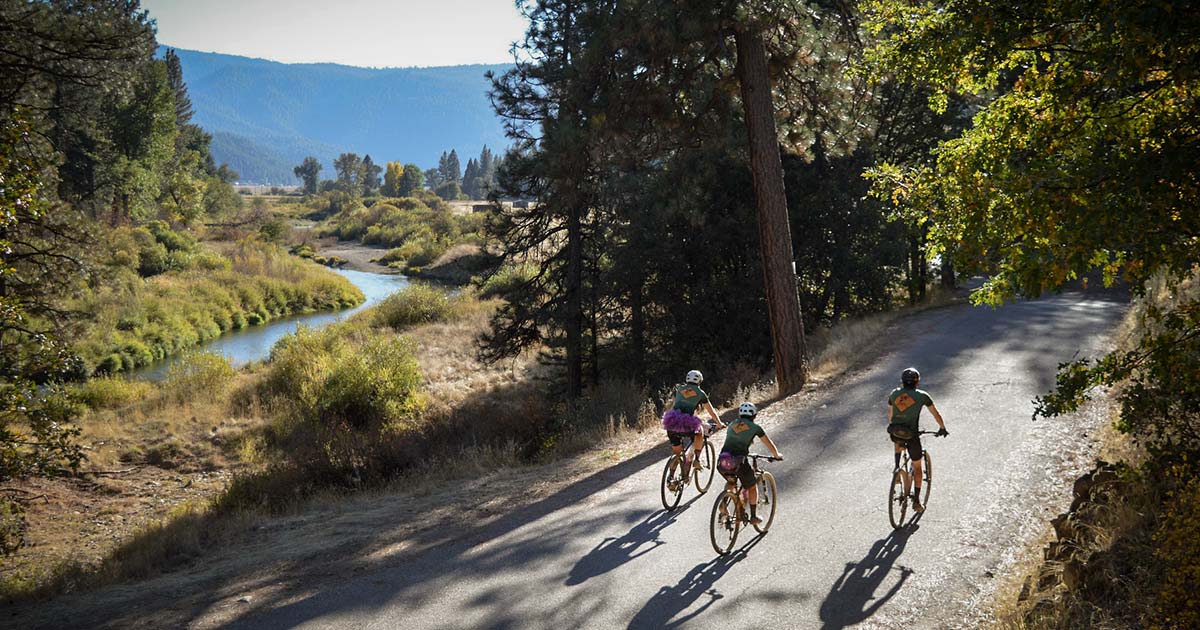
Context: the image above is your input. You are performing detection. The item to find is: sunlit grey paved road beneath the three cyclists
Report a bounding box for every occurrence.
[226,294,1123,629]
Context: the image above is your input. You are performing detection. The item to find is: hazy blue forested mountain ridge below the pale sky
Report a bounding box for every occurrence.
[165,48,509,184]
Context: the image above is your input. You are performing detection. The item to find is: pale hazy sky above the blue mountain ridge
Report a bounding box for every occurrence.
[142,0,526,67]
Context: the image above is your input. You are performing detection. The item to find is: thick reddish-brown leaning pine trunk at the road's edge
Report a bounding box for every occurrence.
[734,28,808,395]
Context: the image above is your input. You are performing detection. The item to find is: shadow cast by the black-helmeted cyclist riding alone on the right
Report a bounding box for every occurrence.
[821,518,920,630]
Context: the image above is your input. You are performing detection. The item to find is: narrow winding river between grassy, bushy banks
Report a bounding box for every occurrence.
[130,269,409,380]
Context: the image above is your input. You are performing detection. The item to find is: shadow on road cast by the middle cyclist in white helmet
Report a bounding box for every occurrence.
[629,534,762,630]
